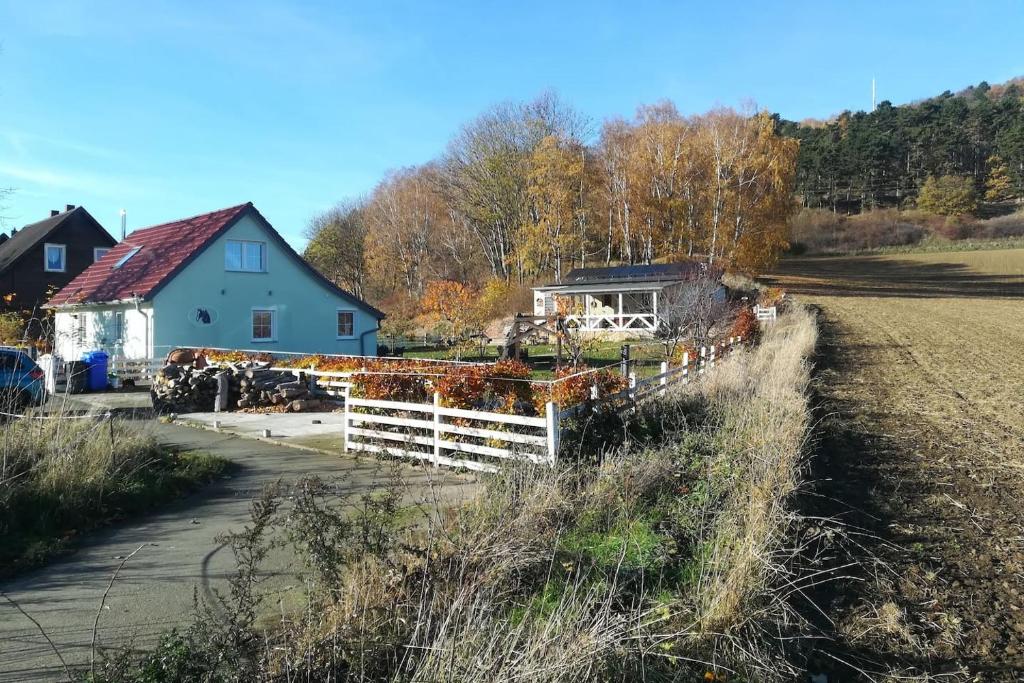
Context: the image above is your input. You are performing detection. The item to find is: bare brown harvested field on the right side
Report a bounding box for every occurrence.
[774,250,1024,681]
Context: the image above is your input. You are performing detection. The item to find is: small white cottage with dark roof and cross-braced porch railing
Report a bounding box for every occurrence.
[534,261,725,337]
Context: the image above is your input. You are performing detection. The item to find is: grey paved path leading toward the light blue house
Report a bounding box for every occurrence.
[0,422,475,682]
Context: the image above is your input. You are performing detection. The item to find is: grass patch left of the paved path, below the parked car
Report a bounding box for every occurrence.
[0,420,228,577]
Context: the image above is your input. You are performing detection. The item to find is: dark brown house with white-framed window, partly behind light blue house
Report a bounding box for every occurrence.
[0,204,117,310]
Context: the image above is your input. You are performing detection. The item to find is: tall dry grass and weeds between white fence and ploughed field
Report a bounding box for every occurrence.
[94,307,815,683]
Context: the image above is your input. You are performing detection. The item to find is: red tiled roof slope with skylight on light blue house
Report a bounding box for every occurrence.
[47,202,255,306]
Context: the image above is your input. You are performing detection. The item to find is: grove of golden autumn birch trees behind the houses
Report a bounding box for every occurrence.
[305,95,798,309]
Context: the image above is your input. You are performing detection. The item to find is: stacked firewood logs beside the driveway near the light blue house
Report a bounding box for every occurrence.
[151,362,322,413]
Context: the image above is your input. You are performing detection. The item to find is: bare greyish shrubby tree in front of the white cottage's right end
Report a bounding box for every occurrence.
[657,272,727,357]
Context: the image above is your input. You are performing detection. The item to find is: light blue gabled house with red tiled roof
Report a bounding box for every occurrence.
[47,203,384,358]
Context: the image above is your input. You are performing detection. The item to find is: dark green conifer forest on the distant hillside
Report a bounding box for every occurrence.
[779,79,1024,213]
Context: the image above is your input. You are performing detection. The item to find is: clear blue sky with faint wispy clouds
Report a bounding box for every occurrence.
[0,0,1024,248]
